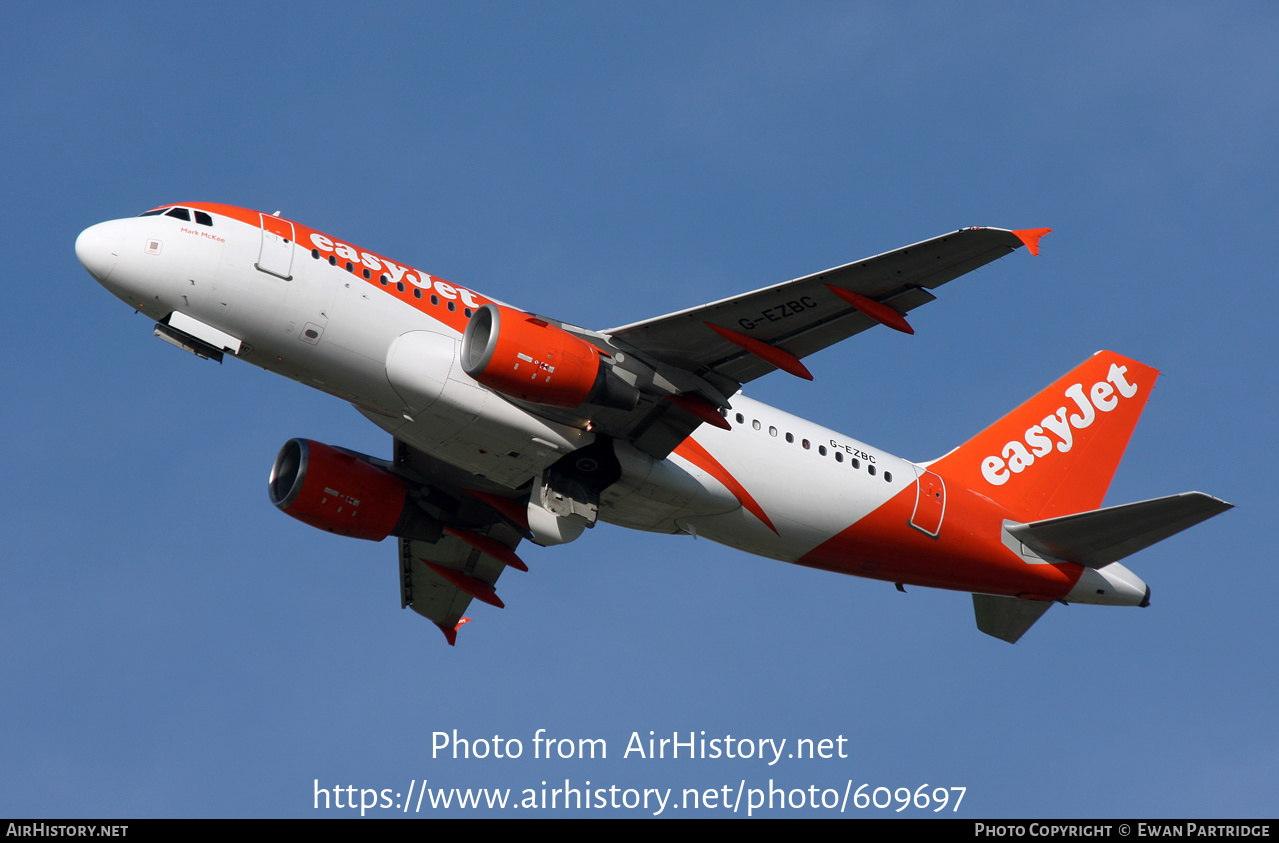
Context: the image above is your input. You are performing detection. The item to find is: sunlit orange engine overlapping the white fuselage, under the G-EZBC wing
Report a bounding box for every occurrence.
[462,303,640,409]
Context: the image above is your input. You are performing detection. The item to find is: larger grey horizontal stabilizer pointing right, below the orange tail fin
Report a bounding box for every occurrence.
[1005,491,1234,568]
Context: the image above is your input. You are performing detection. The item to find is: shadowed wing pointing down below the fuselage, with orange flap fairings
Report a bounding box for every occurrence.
[395,439,528,645]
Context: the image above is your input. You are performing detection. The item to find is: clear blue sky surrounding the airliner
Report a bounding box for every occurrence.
[0,3,1279,817]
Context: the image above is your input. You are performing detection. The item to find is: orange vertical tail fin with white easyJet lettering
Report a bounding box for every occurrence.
[930,352,1159,521]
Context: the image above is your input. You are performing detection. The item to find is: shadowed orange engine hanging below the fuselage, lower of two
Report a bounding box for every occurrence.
[269,439,440,541]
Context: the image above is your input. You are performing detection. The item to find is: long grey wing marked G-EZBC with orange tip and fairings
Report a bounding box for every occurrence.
[592,228,1050,458]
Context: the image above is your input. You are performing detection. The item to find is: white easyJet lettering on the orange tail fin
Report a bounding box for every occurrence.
[981,363,1138,486]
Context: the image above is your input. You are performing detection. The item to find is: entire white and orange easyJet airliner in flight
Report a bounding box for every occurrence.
[75,202,1232,645]
